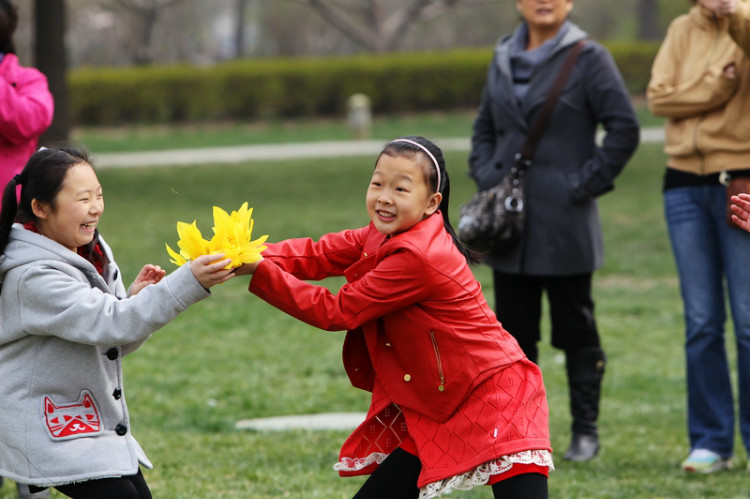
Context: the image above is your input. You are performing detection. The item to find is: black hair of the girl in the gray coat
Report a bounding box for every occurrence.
[0,145,93,254]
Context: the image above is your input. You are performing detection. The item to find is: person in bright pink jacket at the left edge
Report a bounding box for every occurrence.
[0,0,54,190]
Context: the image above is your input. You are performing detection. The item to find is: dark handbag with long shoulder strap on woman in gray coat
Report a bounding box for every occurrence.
[457,39,586,253]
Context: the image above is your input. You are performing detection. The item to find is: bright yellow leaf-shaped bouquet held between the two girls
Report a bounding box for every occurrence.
[166,203,268,268]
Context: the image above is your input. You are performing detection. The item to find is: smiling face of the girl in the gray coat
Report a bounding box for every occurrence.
[31,163,104,251]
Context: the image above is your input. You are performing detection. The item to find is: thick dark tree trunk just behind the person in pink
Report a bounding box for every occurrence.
[34,0,70,143]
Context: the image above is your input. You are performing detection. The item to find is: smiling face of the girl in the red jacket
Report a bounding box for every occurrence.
[366,153,442,236]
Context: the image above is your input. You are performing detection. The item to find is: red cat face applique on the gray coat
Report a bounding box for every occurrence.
[44,390,101,440]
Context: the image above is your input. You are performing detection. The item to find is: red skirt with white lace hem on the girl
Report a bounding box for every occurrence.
[335,359,554,496]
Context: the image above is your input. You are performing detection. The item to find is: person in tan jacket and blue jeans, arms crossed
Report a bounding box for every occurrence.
[647,0,750,473]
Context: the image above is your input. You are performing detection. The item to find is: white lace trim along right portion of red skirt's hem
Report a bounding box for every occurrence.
[419,450,555,499]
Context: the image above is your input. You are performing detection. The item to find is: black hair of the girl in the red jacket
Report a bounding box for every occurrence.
[376,135,479,264]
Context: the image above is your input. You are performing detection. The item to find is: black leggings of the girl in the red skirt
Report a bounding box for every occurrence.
[354,448,548,499]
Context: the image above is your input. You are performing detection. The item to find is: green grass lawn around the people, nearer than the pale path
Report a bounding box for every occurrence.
[0,145,750,499]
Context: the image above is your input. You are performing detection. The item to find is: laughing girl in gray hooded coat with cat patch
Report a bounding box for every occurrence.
[0,149,232,499]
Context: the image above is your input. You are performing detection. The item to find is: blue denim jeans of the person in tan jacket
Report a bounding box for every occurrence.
[664,184,750,457]
